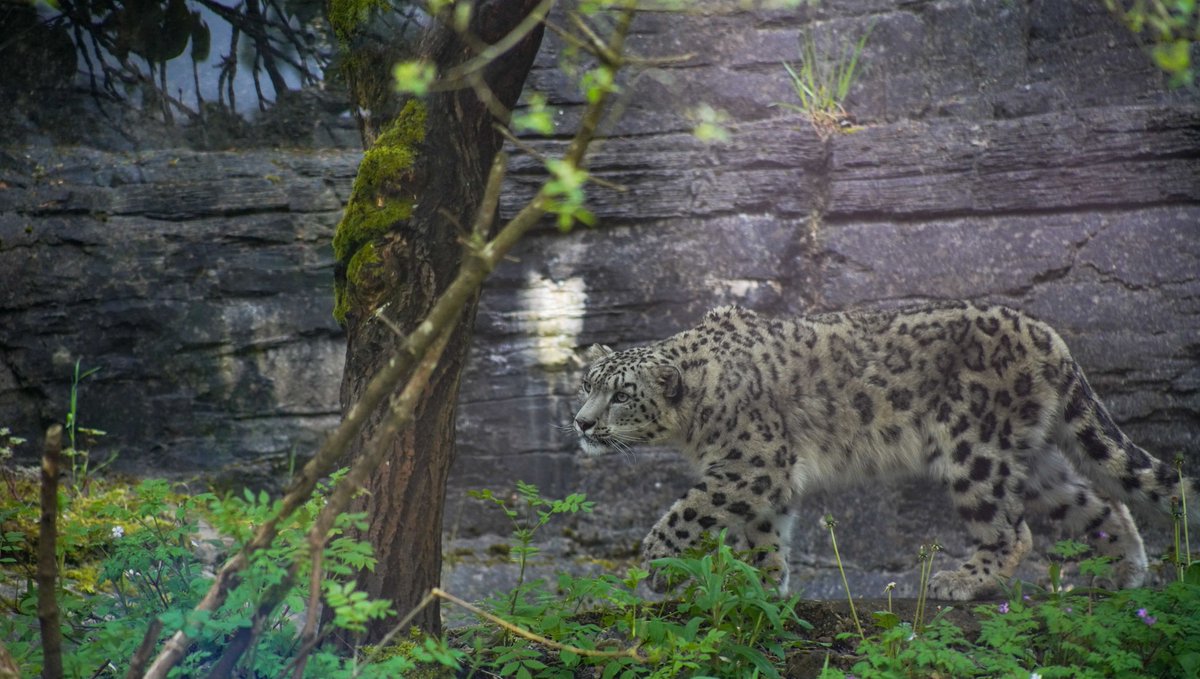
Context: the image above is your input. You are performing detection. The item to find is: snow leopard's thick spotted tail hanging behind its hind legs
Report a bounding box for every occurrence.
[1057,360,1200,525]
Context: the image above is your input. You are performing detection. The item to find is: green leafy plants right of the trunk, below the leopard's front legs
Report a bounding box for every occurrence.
[460,483,808,678]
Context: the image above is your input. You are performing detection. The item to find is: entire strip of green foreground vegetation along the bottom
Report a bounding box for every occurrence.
[0,434,1200,678]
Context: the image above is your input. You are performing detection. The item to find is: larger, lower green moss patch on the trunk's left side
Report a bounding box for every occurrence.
[334,100,426,324]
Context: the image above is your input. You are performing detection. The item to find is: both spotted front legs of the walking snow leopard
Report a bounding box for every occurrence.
[642,468,792,593]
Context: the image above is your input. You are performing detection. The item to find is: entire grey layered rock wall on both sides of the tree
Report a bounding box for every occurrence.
[0,0,1200,595]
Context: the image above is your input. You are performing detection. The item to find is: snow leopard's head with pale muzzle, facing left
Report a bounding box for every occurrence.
[574,344,684,455]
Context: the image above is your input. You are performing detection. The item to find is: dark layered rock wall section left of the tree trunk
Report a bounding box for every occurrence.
[0,148,358,485]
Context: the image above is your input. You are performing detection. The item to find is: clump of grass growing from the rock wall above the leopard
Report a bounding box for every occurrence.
[778,25,874,137]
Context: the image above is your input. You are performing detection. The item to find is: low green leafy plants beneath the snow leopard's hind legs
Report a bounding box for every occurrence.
[822,541,1200,678]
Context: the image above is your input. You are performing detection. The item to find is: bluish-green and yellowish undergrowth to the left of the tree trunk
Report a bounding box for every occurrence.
[0,467,455,677]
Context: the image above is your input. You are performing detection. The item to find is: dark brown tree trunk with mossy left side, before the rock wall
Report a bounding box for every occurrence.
[334,0,541,643]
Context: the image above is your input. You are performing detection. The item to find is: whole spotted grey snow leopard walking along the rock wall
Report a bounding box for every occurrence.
[575,304,1200,600]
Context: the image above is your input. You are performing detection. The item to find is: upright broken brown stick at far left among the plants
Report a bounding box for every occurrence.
[37,425,62,678]
